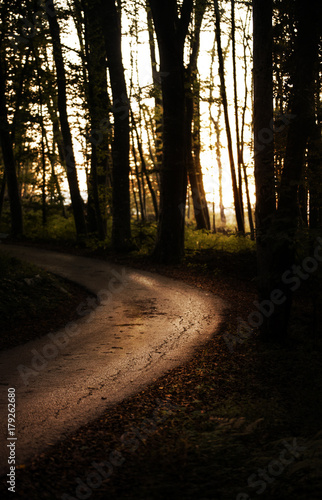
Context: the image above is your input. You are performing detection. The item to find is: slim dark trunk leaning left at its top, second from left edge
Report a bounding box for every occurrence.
[46,0,86,236]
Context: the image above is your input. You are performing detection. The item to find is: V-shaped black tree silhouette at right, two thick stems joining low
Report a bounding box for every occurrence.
[253,0,321,343]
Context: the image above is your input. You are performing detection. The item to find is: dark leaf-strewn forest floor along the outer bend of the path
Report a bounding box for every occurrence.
[0,239,322,500]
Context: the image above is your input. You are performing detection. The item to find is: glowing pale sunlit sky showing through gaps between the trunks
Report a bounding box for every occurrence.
[62,1,255,220]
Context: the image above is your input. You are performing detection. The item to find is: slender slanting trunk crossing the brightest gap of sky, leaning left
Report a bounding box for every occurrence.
[214,0,245,234]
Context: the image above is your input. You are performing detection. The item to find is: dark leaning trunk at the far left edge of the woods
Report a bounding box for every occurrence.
[0,46,23,236]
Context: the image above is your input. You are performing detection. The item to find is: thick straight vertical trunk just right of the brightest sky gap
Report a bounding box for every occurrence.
[253,0,276,338]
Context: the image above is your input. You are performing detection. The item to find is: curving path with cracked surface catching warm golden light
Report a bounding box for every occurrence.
[0,245,225,474]
